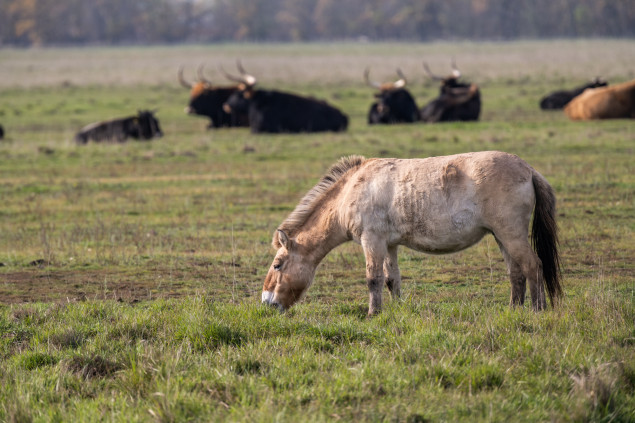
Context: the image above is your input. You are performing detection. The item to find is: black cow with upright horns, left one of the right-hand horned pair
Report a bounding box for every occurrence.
[364,68,419,125]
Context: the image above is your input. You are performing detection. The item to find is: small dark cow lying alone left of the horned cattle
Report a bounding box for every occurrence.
[75,110,163,144]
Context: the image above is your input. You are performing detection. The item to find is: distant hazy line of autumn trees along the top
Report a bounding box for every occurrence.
[0,0,635,46]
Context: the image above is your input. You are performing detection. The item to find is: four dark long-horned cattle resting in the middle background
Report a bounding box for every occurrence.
[178,62,481,133]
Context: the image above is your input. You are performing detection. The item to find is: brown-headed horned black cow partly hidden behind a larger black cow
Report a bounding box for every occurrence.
[178,65,249,128]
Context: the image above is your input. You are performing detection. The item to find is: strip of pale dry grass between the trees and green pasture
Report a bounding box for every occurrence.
[0,39,635,88]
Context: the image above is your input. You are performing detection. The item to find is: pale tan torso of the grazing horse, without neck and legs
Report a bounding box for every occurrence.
[340,151,534,253]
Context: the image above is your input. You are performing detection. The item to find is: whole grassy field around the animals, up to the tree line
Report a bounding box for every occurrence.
[0,40,635,422]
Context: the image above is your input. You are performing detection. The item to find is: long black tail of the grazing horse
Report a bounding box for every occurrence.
[531,171,562,306]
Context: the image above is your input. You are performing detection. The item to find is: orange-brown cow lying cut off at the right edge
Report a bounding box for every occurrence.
[564,79,635,120]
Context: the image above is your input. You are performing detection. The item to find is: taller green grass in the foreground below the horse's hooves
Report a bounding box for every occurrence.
[1,296,635,421]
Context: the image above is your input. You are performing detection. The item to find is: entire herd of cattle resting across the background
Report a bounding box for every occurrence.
[7,61,635,144]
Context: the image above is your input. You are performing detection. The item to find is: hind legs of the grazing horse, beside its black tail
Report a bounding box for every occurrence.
[497,238,547,310]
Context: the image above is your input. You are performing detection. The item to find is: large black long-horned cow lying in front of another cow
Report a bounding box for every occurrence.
[223,62,348,133]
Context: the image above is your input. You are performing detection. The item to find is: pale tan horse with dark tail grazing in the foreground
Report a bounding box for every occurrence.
[262,151,562,316]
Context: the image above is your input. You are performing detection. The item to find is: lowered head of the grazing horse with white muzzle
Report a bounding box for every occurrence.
[262,230,316,311]
